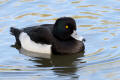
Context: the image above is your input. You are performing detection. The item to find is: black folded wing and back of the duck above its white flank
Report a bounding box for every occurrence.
[23,24,53,44]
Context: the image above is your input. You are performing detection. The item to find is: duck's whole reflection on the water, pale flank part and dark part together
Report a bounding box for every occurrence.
[11,43,84,76]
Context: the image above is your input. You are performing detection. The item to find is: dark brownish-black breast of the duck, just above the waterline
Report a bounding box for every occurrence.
[52,40,85,54]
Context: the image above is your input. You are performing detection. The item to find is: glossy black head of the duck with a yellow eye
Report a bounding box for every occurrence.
[53,17,76,40]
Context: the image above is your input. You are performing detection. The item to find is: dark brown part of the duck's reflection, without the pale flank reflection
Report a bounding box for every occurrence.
[32,53,83,76]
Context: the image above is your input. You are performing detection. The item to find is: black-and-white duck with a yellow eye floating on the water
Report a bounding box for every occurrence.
[10,17,85,54]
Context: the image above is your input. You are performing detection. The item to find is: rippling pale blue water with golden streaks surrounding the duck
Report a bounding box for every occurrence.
[0,0,120,80]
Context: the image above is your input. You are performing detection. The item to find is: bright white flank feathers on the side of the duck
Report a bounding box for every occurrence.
[19,32,51,54]
